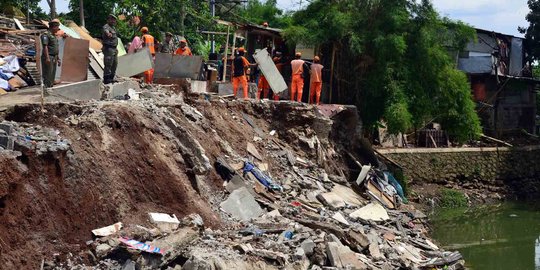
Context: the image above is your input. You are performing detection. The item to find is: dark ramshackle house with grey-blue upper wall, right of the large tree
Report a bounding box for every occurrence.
[457,29,539,137]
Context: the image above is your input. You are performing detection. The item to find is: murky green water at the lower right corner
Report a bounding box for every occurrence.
[431,202,540,270]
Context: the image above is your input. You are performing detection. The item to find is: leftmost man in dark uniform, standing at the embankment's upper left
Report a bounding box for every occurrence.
[40,21,60,88]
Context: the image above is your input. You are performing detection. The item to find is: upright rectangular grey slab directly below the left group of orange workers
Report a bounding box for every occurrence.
[154,53,202,80]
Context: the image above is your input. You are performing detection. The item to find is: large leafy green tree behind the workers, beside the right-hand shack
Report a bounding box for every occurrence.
[284,0,481,141]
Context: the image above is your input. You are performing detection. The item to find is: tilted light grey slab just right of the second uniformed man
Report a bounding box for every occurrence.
[116,48,154,77]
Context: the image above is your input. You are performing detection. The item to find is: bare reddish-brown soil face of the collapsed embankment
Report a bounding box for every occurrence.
[0,99,354,269]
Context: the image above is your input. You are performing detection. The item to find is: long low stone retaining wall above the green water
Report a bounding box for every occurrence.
[378,146,540,190]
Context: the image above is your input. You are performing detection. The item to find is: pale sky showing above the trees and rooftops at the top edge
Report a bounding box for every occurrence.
[41,0,529,36]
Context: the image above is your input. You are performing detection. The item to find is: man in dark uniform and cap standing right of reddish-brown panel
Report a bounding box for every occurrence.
[102,15,118,84]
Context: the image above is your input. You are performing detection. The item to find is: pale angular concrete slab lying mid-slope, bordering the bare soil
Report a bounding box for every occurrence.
[220,187,264,221]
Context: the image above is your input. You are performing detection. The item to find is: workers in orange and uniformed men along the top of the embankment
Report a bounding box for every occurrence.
[40,15,323,104]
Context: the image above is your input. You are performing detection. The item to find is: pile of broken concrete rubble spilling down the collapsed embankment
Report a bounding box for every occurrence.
[3,88,463,270]
